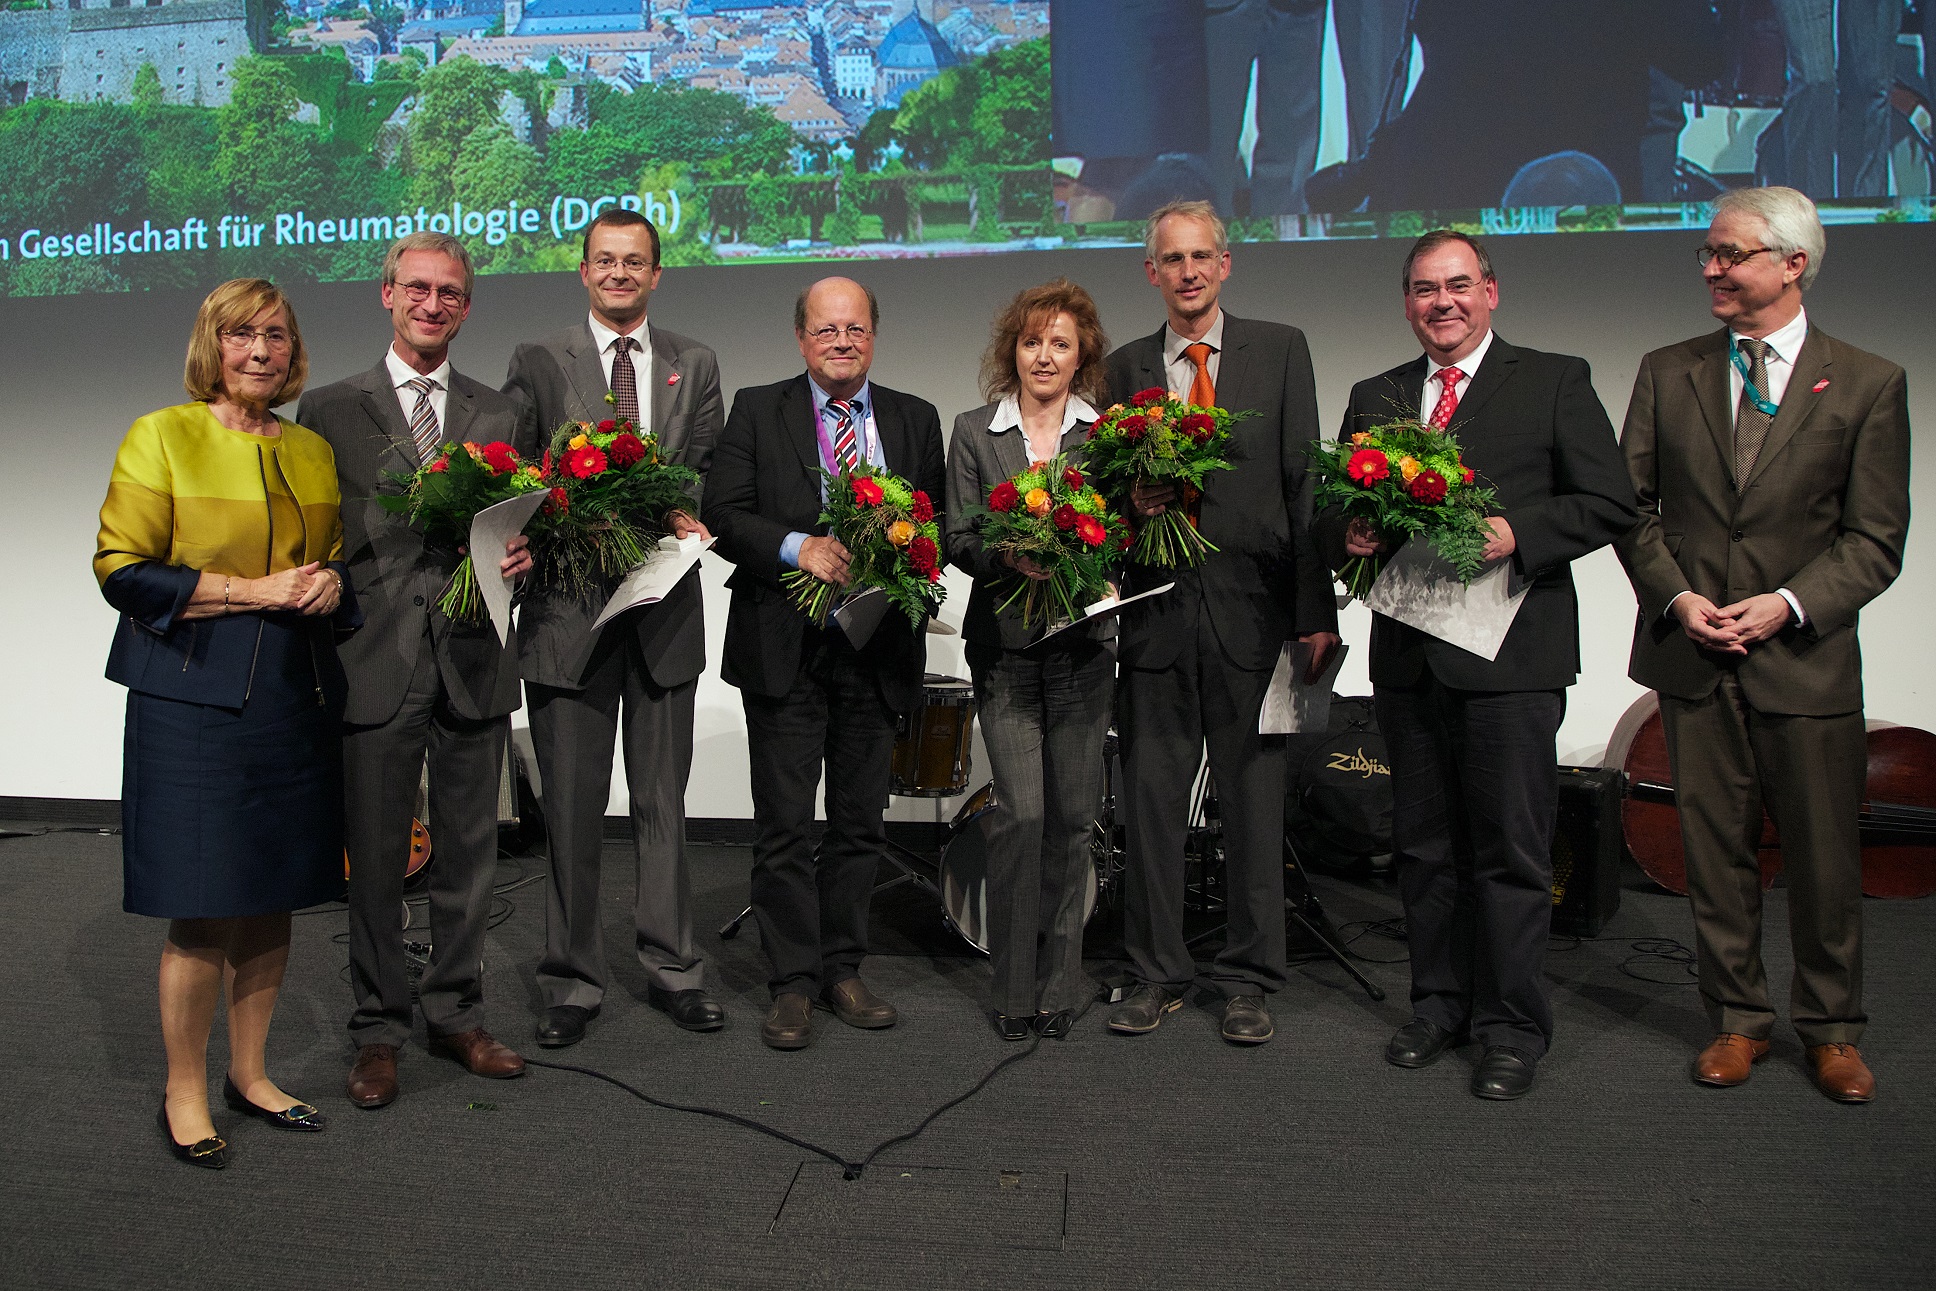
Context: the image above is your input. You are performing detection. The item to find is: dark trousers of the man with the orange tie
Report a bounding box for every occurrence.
[1117,610,1286,997]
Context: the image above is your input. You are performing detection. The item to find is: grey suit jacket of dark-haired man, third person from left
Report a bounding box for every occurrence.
[503,323,724,691]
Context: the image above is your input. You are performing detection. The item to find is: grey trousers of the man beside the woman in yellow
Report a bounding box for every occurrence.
[343,633,509,1047]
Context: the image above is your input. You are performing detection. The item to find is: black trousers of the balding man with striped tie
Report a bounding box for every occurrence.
[741,629,894,997]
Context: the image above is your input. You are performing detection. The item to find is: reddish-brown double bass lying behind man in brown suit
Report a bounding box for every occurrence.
[1607,691,1936,898]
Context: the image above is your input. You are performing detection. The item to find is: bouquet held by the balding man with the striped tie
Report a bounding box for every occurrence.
[780,463,947,627]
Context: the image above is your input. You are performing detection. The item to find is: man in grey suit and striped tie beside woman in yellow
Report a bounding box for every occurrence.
[296,232,536,1107]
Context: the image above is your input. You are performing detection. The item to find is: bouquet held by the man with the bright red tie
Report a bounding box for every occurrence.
[1311,418,1495,596]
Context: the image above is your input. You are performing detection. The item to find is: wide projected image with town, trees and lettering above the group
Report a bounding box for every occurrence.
[0,0,1936,296]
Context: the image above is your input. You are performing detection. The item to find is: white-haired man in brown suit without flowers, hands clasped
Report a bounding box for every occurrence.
[1618,188,1909,1103]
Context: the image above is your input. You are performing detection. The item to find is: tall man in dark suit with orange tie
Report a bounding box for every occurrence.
[1109,201,1338,1045]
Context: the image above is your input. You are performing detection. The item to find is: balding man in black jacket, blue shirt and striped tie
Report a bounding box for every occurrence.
[705,279,947,1049]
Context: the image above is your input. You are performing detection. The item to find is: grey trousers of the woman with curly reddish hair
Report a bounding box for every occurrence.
[968,639,1115,1018]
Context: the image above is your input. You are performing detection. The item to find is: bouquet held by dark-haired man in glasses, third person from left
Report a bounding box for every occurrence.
[540,418,699,594]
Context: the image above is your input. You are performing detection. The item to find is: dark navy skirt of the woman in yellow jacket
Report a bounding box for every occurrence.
[122,621,343,919]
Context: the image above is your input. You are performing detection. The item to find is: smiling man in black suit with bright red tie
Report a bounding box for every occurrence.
[1313,230,1634,1099]
